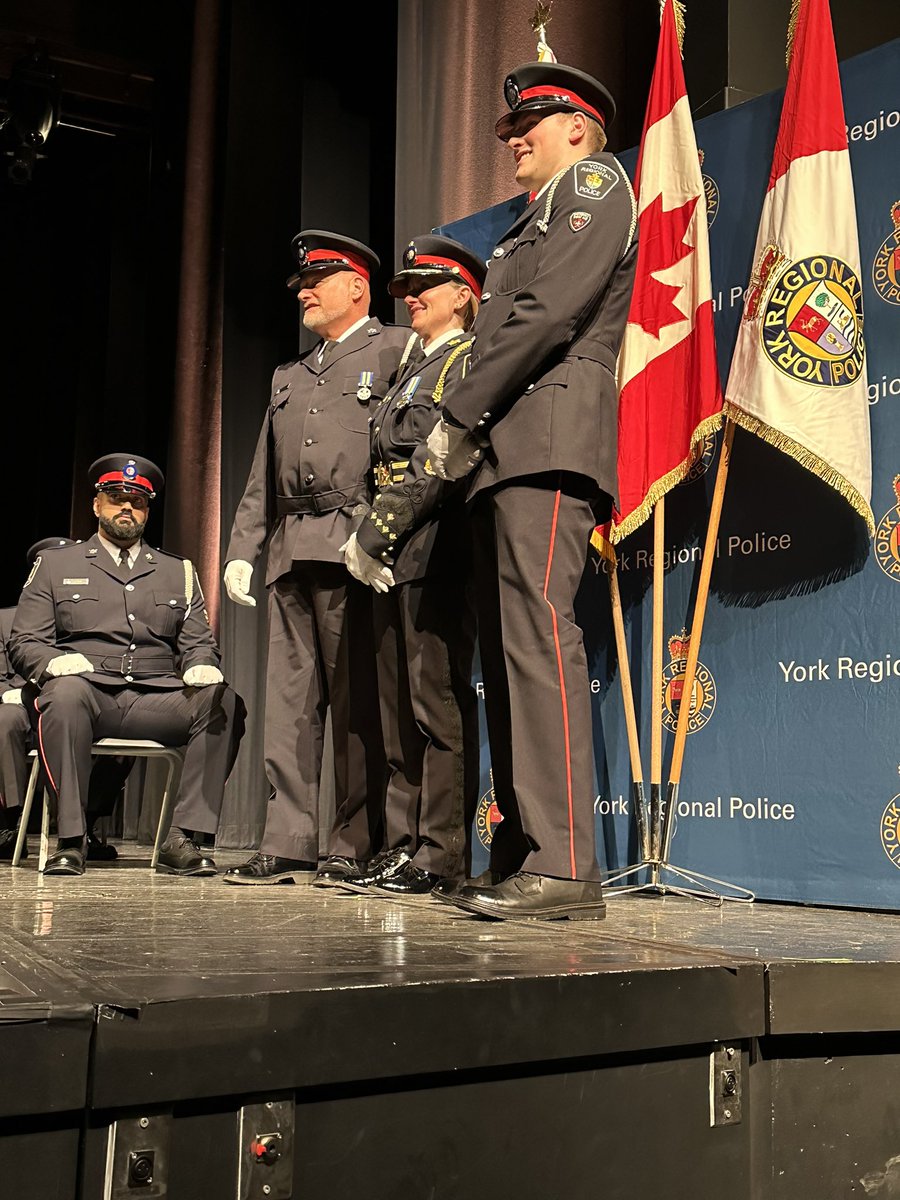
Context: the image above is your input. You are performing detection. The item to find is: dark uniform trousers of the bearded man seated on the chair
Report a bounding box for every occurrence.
[37,676,246,838]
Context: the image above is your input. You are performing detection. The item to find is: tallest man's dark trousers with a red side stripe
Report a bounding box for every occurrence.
[473,474,600,880]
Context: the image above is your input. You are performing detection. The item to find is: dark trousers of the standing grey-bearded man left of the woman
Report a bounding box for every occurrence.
[259,562,385,863]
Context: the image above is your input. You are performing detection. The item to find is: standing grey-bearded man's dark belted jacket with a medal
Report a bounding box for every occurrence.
[226,318,409,583]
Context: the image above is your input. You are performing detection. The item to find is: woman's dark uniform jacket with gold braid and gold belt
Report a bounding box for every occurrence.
[356,330,473,583]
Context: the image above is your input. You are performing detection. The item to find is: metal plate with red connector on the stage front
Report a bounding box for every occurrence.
[238,1096,294,1200]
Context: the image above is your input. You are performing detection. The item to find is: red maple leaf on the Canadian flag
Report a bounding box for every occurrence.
[628,196,700,337]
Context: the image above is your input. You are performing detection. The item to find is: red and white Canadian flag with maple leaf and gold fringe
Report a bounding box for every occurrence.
[611,0,722,542]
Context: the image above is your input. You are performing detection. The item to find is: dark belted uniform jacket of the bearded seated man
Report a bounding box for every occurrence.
[10,534,220,690]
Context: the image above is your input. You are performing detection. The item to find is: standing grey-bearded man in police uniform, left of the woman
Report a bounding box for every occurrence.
[224,229,409,883]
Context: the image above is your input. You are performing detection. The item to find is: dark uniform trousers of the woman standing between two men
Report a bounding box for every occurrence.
[373,577,479,878]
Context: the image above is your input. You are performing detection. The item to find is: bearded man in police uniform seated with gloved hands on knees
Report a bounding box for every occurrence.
[10,454,246,875]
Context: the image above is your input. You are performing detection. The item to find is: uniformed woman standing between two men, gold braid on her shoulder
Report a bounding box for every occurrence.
[346,235,485,896]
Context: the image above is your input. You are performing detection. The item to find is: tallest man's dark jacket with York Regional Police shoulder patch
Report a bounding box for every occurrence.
[445,154,637,496]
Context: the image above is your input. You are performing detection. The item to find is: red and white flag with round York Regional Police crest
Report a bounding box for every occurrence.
[726,0,875,532]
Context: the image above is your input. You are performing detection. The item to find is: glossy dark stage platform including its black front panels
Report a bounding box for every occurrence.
[0,839,900,1200]
